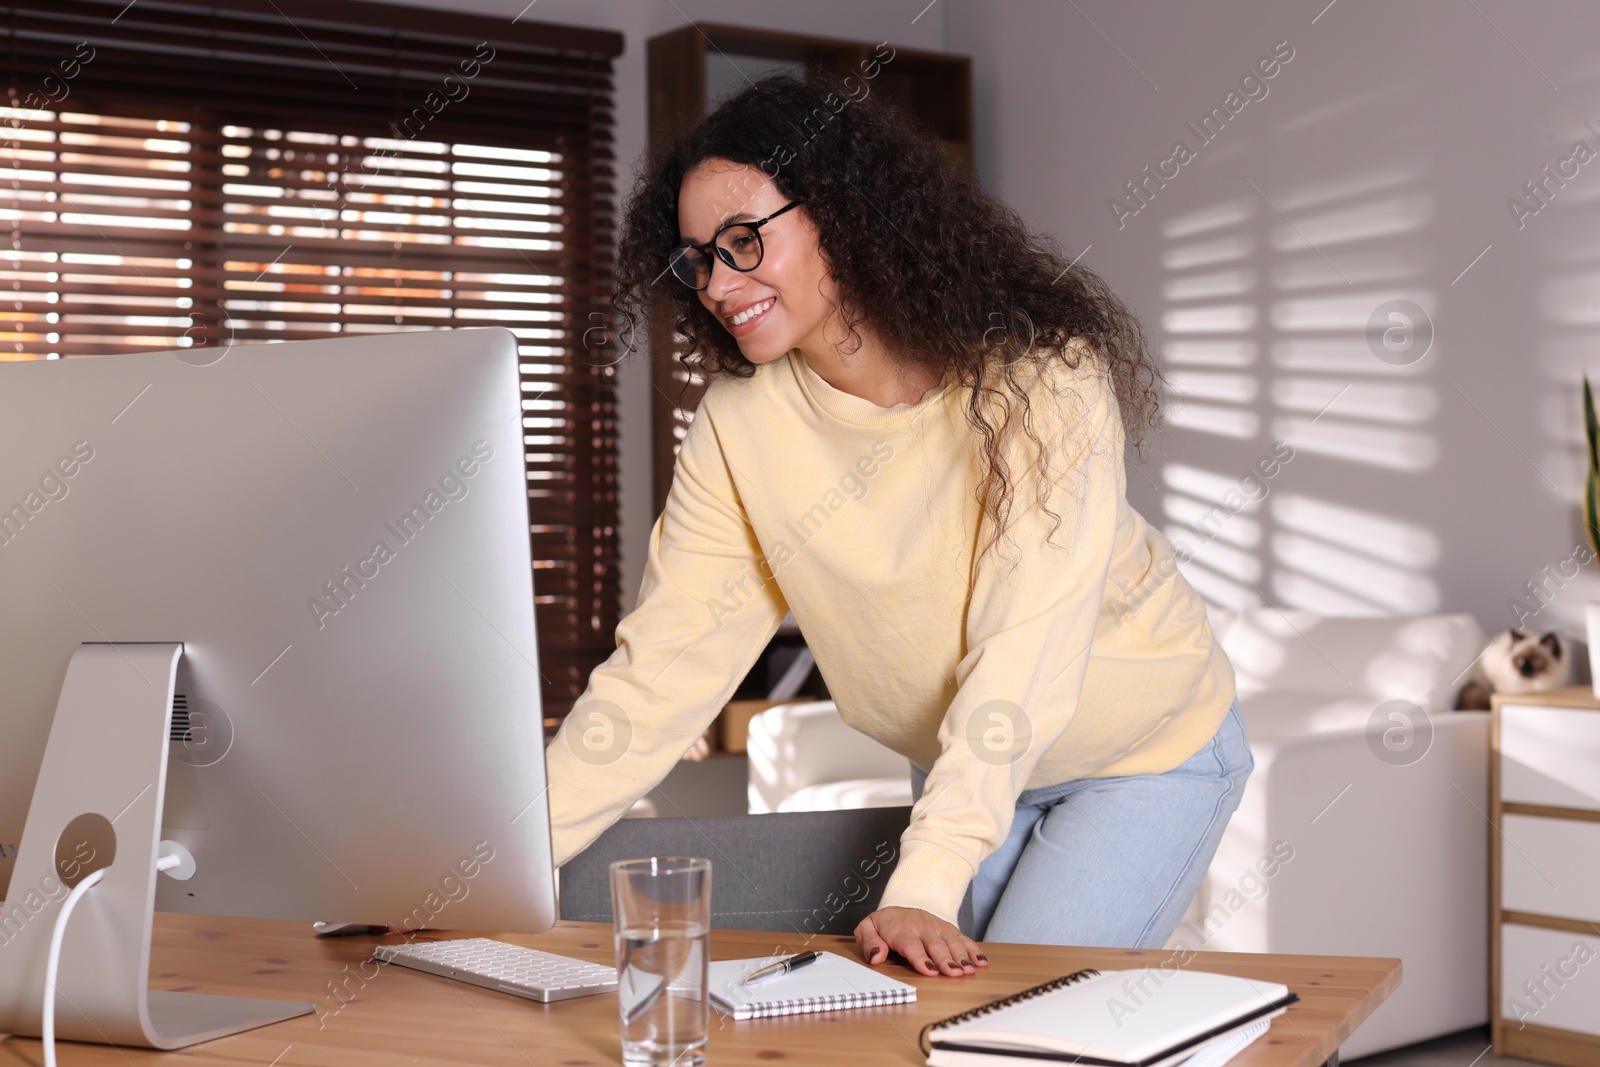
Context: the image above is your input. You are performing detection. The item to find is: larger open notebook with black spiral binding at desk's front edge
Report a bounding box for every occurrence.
[922,969,1299,1067]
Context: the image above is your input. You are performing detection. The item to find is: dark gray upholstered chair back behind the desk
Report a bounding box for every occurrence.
[562,808,910,934]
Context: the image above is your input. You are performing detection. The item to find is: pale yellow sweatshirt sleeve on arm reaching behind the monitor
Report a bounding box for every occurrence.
[546,384,789,867]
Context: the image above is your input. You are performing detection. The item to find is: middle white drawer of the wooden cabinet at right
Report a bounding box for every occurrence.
[1501,816,1600,921]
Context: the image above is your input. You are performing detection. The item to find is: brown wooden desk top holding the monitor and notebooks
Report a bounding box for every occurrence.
[0,913,1400,1067]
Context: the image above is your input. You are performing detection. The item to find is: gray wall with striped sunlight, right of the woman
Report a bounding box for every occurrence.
[947,0,1600,655]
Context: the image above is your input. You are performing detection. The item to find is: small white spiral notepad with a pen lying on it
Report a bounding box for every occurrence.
[706,952,917,1019]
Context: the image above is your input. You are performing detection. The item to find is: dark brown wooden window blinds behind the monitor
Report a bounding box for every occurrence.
[0,0,622,728]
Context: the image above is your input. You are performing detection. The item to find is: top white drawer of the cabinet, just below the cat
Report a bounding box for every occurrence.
[1499,704,1600,809]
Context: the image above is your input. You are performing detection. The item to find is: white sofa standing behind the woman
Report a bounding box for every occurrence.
[749,608,1490,1059]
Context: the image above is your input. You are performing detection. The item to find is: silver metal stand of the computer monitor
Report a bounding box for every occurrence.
[0,641,315,1049]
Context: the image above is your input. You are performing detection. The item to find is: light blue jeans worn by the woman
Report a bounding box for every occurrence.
[912,699,1256,949]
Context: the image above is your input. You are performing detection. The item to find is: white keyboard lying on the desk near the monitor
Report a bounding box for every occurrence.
[373,937,616,1001]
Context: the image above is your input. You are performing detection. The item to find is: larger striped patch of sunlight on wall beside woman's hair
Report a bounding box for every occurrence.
[1158,93,1440,614]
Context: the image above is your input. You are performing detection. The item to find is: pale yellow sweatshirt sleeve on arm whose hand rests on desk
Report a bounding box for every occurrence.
[882,352,1126,923]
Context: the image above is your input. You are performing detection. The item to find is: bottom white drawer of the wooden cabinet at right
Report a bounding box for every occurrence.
[1496,923,1600,1037]
